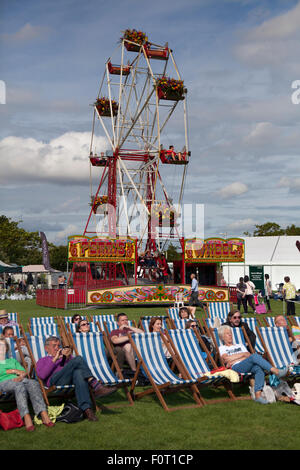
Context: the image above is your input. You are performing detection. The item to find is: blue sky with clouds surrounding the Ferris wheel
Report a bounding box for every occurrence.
[0,0,300,248]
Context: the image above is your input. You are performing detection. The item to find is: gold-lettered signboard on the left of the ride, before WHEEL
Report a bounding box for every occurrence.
[68,235,136,263]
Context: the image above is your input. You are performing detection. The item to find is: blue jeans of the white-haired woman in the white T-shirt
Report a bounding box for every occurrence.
[231,353,272,392]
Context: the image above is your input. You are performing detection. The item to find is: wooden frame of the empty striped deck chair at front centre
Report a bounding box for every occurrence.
[129,333,204,412]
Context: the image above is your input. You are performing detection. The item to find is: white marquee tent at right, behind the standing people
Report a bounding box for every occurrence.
[223,236,300,290]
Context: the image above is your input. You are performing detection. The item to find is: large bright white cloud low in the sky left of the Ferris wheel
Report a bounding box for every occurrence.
[0,132,108,185]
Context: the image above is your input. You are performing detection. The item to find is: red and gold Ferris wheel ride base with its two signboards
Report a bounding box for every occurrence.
[35,236,244,308]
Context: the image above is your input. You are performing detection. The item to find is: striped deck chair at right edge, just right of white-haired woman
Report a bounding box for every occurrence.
[256,326,300,378]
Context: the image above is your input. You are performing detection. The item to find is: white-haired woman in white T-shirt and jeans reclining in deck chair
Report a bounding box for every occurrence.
[218,325,288,405]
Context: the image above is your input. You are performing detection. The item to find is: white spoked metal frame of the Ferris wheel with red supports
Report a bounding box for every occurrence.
[84,31,190,258]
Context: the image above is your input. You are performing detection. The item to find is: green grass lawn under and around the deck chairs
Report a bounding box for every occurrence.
[0,301,300,450]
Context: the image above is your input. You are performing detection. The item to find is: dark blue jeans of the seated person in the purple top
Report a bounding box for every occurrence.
[50,356,93,411]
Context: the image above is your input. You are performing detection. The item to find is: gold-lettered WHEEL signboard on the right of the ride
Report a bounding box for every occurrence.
[184,238,245,263]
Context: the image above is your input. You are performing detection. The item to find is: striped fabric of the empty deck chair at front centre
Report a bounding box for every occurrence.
[131,333,196,385]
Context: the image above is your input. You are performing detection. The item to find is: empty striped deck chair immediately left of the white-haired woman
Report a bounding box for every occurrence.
[165,329,236,403]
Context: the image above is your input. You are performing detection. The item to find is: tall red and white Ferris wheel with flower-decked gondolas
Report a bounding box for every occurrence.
[84,30,190,255]
